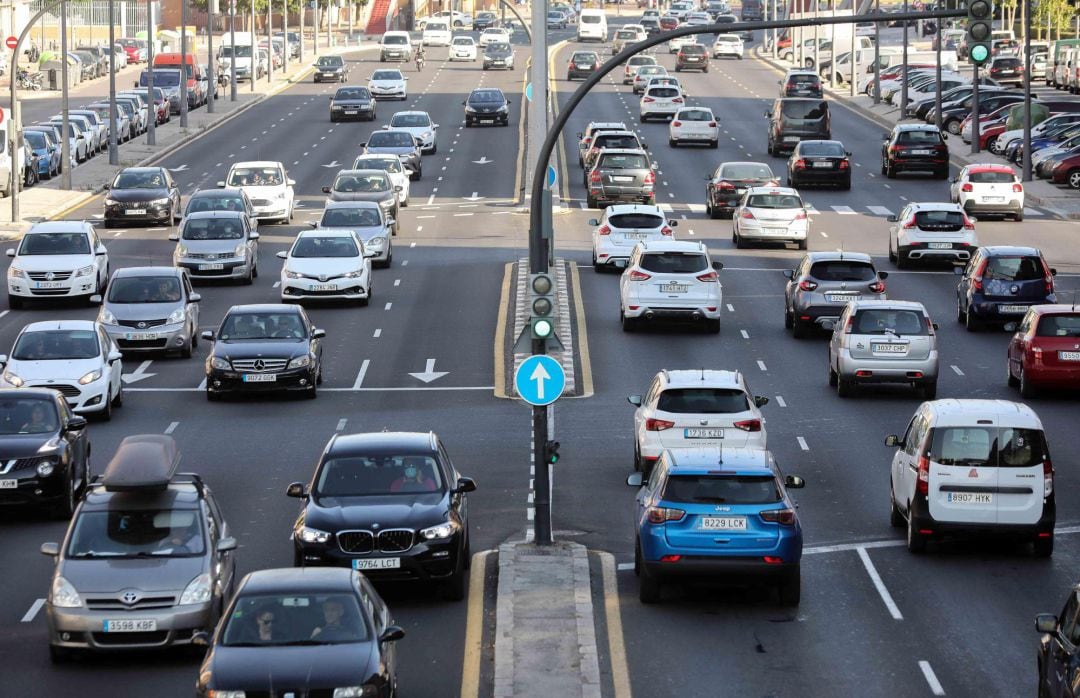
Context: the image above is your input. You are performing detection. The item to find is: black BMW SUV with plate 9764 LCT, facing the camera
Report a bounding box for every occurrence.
[286,431,476,601]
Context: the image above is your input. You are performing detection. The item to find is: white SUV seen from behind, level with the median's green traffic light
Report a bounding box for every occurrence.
[616,240,724,333]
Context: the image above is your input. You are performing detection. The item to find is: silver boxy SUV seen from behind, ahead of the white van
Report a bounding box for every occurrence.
[823,300,937,400]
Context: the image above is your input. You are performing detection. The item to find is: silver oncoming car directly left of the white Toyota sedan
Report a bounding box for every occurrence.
[168,211,259,284]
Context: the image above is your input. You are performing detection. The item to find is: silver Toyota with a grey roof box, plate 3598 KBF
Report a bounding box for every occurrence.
[41,434,237,661]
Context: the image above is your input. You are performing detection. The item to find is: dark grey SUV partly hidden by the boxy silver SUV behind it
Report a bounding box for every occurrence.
[784,252,889,338]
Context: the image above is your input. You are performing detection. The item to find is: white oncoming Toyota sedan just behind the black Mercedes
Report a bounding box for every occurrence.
[278,231,378,306]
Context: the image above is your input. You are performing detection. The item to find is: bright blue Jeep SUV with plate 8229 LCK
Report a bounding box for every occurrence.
[626,447,805,606]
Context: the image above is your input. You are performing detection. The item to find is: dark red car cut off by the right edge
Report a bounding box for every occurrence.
[1008,304,1080,398]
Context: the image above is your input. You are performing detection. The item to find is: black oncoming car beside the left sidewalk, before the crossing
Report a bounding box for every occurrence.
[105,167,180,228]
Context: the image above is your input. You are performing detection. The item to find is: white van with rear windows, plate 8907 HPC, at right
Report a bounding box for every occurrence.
[885,400,1056,558]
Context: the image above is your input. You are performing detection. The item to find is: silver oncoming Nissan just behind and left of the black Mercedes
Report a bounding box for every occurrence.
[92,267,202,359]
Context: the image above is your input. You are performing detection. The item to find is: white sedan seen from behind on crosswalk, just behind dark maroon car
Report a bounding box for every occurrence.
[731,187,810,250]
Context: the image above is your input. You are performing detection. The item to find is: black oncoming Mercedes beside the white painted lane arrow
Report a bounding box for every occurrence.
[202,304,326,401]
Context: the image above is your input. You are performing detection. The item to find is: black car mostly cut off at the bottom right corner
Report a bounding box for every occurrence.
[1035,582,1080,698]
